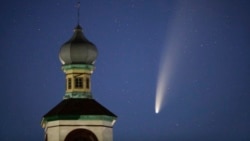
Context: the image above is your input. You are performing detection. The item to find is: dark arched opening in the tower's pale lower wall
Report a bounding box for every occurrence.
[65,129,98,141]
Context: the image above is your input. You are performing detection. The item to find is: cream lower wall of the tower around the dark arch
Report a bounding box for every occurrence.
[45,120,113,141]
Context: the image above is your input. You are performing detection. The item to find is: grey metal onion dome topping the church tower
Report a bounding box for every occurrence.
[59,25,97,65]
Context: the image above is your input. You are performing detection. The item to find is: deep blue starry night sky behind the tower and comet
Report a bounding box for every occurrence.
[0,0,250,141]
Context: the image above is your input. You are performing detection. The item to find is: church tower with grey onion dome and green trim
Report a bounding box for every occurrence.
[41,2,117,141]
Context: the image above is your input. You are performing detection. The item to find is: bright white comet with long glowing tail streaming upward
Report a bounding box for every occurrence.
[155,1,192,114]
